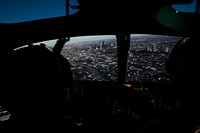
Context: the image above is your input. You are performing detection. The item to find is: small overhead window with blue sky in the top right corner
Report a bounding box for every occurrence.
[172,0,200,13]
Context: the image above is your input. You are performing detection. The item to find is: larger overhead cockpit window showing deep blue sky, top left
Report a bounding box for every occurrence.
[0,0,79,23]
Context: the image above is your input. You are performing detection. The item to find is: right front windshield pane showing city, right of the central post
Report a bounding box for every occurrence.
[126,34,181,82]
